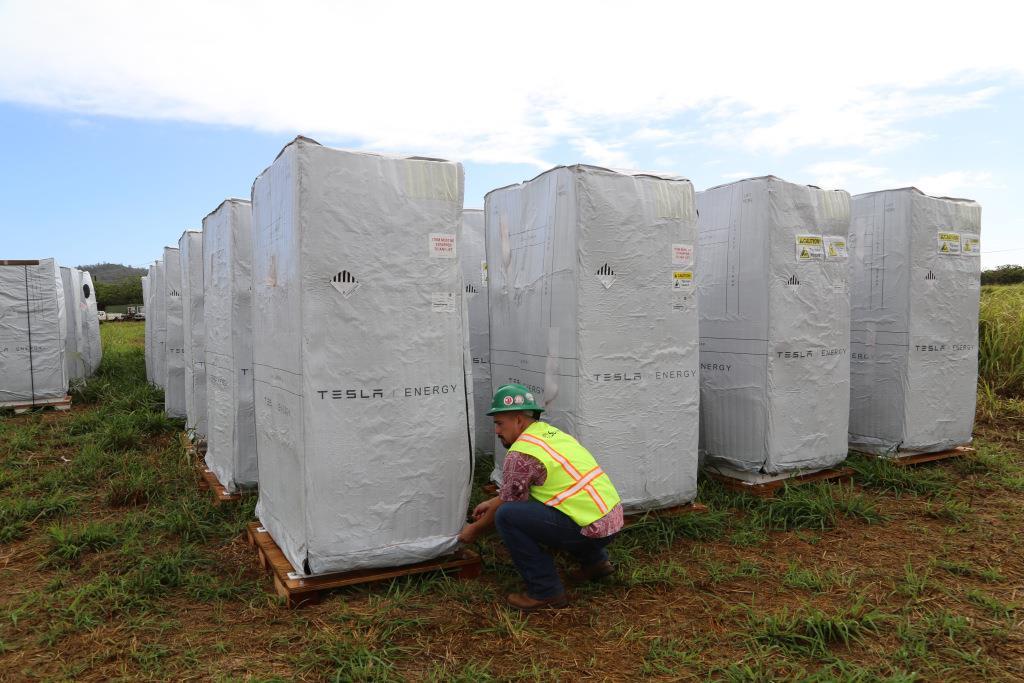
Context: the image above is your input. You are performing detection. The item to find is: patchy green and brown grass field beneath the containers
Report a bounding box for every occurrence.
[0,311,1024,681]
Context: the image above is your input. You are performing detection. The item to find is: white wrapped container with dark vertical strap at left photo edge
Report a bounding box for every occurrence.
[0,258,68,405]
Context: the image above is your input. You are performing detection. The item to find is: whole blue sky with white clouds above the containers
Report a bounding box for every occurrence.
[0,0,1024,268]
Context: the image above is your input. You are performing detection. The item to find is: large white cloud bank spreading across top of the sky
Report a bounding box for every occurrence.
[0,0,1024,166]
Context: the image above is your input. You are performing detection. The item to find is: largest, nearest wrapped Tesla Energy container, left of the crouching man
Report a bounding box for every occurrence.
[252,137,472,573]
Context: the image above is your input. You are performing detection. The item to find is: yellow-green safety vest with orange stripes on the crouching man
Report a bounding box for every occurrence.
[509,422,620,526]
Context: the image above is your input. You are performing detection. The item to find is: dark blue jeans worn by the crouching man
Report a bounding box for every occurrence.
[495,500,615,600]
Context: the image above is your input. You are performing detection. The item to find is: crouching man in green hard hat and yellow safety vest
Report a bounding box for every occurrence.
[459,384,623,611]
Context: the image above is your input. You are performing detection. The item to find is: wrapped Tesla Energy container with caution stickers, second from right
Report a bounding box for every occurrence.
[697,176,850,475]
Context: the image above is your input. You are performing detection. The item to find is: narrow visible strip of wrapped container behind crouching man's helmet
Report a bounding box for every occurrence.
[459,209,495,455]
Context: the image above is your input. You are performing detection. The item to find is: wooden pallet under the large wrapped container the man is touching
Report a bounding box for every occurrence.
[246,522,482,607]
